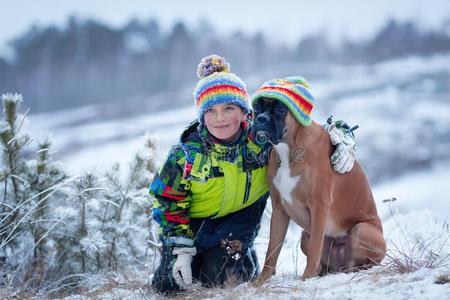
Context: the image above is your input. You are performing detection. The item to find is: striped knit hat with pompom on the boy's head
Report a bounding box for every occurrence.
[194,54,250,123]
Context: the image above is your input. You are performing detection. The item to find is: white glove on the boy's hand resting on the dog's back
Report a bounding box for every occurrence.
[327,126,356,173]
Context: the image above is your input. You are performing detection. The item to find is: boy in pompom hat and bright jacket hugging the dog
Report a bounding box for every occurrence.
[150,55,354,294]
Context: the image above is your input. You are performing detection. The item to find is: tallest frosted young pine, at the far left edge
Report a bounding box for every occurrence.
[0,94,67,286]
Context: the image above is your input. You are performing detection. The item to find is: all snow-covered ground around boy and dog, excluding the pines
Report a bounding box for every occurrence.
[25,55,450,299]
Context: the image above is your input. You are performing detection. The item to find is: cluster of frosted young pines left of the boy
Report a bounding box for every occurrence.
[0,94,159,291]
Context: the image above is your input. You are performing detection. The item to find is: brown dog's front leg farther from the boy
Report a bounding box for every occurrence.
[302,194,330,280]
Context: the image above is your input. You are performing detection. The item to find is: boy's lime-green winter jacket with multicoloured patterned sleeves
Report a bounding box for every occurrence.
[150,122,270,246]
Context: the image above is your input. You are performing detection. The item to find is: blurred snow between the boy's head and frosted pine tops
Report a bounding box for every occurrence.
[26,106,196,173]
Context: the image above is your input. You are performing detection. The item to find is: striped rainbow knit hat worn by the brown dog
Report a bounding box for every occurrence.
[252,76,315,126]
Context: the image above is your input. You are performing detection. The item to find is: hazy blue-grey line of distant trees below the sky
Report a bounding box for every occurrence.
[0,17,450,112]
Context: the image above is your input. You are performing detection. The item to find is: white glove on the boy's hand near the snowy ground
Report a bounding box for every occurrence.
[172,247,197,288]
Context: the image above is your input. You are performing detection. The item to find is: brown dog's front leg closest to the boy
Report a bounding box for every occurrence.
[255,186,289,286]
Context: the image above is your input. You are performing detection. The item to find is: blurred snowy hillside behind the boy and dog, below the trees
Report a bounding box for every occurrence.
[29,54,450,183]
